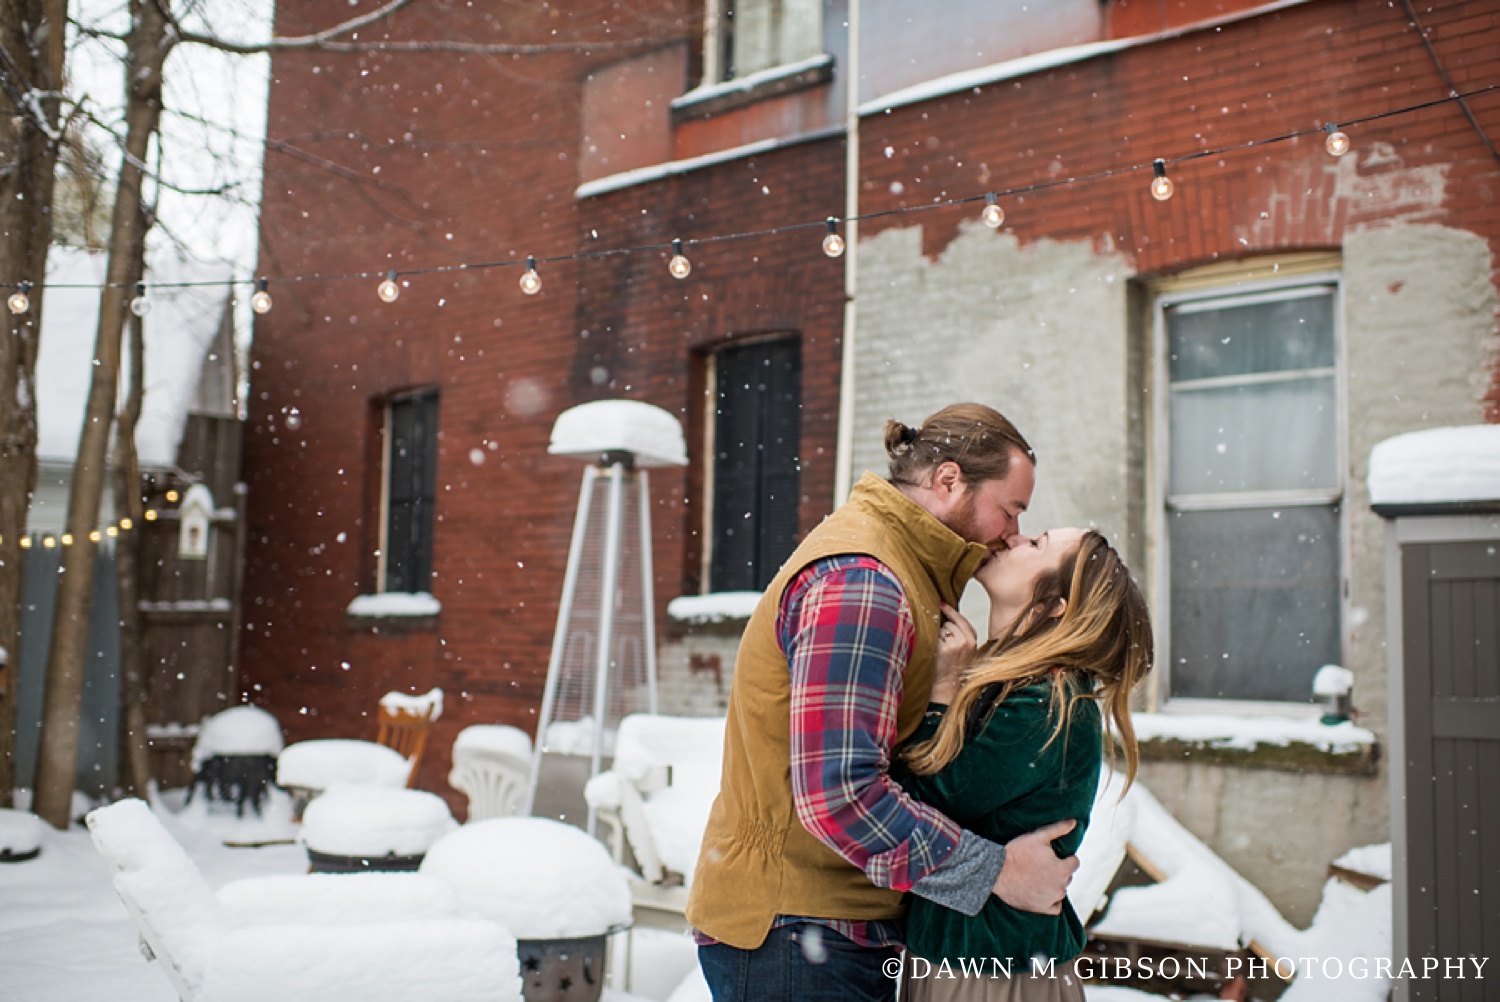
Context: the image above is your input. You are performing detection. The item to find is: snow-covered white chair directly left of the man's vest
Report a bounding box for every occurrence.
[584,714,725,929]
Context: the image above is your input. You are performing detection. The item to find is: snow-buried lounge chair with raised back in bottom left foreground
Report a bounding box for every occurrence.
[87,800,522,1002]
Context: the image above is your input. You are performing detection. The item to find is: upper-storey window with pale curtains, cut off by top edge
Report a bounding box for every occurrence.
[704,0,824,84]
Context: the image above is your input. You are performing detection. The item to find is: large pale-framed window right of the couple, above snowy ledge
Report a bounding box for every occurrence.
[1157,279,1344,702]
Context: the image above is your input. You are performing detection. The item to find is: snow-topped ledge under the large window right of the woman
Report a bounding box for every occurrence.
[1131,713,1379,776]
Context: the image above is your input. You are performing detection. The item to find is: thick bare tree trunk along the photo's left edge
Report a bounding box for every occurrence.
[0,0,68,807]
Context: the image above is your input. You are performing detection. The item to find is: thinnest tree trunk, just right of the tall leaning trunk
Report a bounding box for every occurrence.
[114,229,152,797]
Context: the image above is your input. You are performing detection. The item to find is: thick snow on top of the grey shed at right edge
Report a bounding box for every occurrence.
[1370,425,1500,504]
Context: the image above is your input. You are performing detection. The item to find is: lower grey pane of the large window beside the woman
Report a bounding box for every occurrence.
[1167,506,1340,702]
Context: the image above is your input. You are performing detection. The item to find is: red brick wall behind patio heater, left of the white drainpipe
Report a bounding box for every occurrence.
[243,2,843,797]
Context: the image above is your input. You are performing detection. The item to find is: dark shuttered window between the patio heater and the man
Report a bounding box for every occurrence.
[710,339,803,591]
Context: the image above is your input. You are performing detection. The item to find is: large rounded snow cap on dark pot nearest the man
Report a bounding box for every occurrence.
[422,818,630,939]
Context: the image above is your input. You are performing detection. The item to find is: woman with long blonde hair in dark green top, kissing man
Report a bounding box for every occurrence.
[891,528,1152,1002]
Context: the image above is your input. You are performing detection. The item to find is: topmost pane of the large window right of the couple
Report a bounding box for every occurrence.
[1167,288,1334,383]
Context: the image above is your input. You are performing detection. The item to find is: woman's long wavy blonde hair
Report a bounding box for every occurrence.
[905,531,1155,789]
